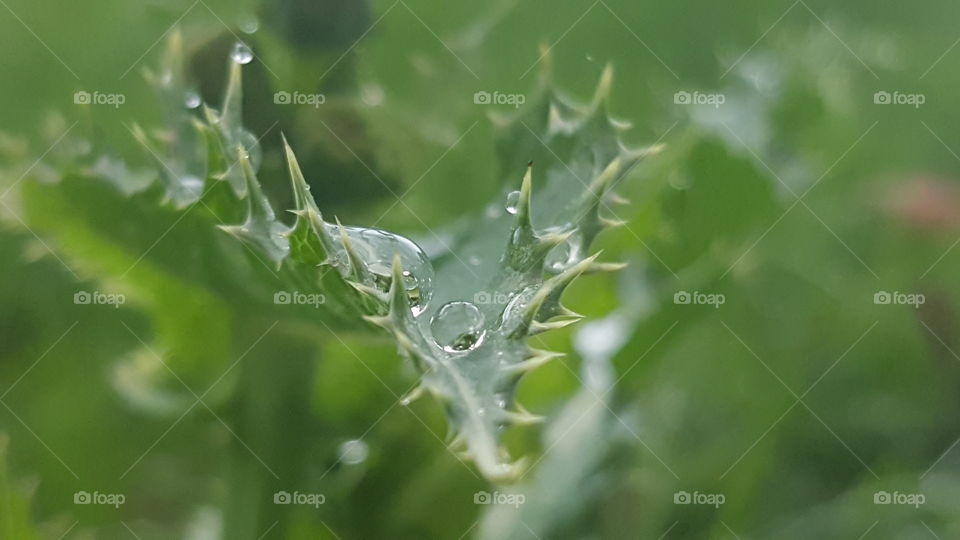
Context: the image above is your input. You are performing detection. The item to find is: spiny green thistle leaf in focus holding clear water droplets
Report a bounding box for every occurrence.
[20,32,649,481]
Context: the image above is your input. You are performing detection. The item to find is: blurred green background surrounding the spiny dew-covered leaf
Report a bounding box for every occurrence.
[0,0,960,539]
